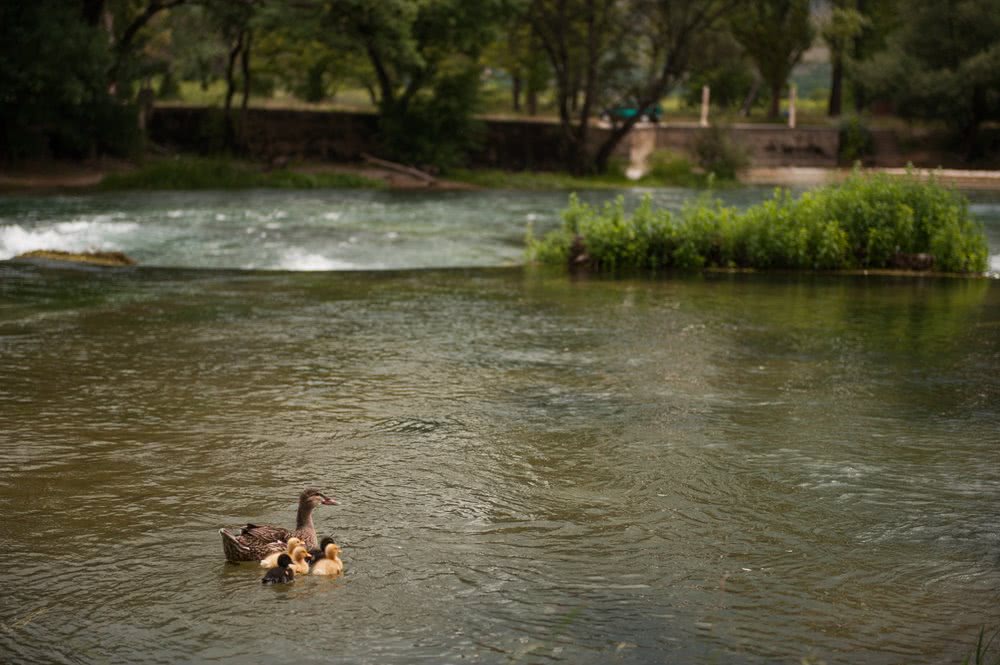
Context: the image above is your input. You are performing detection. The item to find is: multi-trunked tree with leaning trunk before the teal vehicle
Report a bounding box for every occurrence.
[528,0,746,173]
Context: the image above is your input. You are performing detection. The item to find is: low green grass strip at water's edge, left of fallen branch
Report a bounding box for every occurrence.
[100,158,382,190]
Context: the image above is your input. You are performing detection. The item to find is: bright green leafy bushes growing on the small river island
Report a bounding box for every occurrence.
[528,172,988,273]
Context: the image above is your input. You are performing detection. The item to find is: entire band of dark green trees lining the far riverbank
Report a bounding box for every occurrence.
[0,0,1000,167]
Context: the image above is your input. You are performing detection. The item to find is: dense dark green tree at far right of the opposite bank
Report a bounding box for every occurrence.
[858,0,1000,159]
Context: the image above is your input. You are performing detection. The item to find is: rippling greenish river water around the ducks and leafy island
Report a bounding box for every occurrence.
[0,185,1000,663]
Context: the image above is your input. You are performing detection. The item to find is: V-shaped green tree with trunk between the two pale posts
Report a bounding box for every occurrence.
[730,0,813,119]
